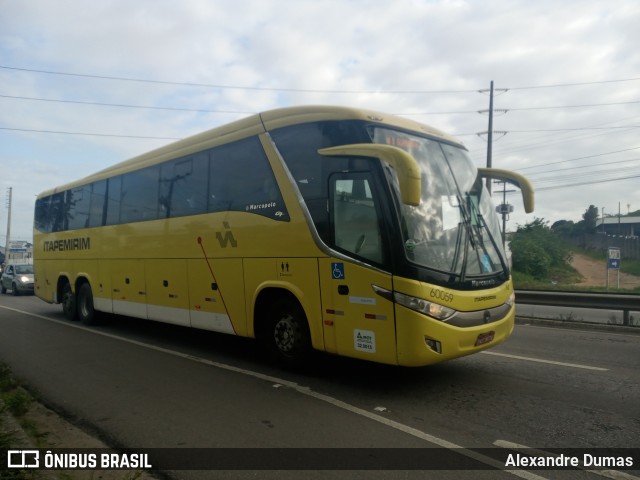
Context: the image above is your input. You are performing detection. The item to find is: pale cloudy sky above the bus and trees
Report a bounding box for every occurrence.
[0,0,640,245]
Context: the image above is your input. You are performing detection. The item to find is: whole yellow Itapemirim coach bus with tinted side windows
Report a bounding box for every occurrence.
[34,106,533,366]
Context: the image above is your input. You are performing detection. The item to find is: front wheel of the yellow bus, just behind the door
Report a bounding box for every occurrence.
[262,297,312,367]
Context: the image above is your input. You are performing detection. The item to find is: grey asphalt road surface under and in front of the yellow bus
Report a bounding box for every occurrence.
[0,295,640,480]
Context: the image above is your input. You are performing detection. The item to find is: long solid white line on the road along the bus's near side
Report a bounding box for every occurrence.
[0,305,546,480]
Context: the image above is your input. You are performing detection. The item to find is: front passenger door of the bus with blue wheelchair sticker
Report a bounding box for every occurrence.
[319,173,397,364]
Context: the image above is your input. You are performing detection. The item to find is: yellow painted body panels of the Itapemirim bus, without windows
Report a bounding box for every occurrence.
[34,107,515,366]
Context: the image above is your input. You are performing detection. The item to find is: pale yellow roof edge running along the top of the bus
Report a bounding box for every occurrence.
[38,105,463,198]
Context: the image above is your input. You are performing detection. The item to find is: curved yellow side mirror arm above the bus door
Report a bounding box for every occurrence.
[318,143,422,206]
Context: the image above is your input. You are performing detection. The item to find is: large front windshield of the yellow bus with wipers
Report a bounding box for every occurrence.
[373,128,507,281]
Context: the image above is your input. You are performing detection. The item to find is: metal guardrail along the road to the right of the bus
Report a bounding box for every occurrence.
[516,290,640,326]
